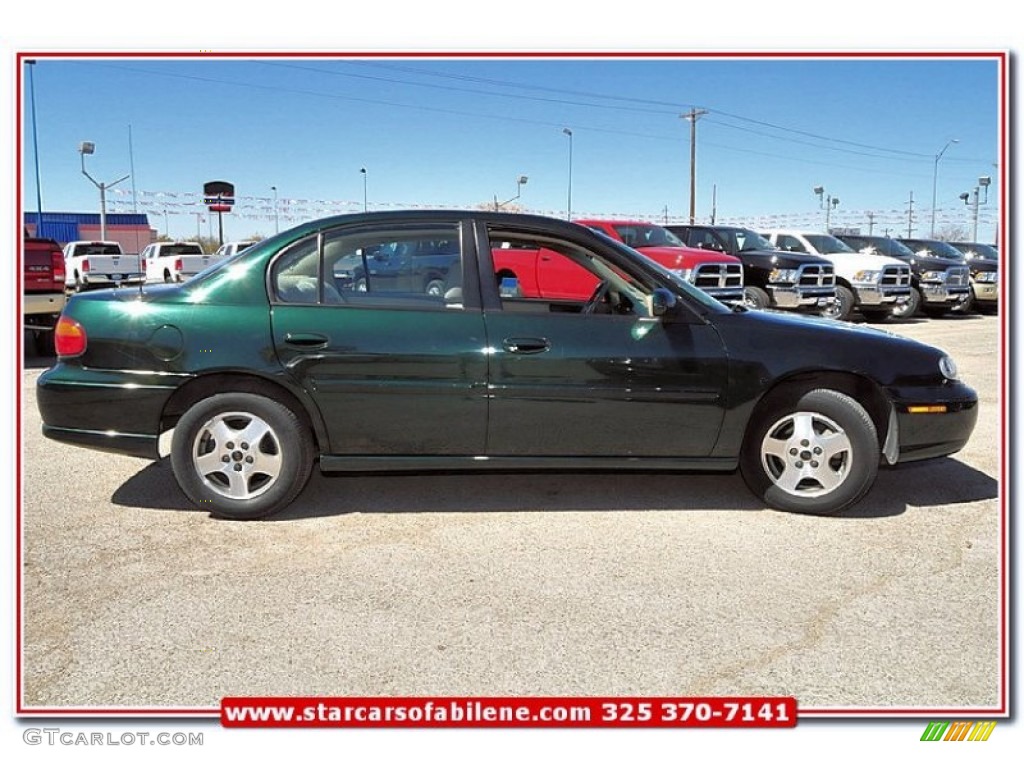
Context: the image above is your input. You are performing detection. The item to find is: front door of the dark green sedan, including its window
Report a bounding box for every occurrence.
[477,223,727,458]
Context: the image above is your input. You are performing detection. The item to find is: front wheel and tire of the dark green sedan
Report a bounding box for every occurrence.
[739,389,881,515]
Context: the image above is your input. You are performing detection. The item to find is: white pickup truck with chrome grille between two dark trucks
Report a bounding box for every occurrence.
[762,229,910,323]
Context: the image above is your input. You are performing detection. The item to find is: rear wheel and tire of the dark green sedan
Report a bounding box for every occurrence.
[171,392,313,520]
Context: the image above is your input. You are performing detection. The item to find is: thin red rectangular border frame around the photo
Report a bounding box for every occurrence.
[13,50,1013,718]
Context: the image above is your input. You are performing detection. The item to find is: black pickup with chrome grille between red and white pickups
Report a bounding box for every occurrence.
[668,224,836,311]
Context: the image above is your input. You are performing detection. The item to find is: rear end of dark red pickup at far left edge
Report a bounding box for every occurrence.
[22,237,67,355]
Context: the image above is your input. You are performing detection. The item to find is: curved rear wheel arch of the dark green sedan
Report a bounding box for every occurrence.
[160,371,330,454]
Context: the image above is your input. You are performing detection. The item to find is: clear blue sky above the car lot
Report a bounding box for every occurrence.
[24,57,999,241]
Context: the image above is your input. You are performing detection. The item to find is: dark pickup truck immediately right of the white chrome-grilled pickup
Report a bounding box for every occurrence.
[840,234,970,319]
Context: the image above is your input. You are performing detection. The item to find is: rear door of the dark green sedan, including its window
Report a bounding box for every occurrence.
[268,219,487,458]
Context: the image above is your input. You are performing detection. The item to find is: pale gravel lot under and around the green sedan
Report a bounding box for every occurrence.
[22,316,1000,710]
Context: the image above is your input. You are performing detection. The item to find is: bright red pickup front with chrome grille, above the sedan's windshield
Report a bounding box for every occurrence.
[577,219,743,302]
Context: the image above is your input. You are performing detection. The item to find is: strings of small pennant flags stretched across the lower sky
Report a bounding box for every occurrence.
[108,189,997,233]
